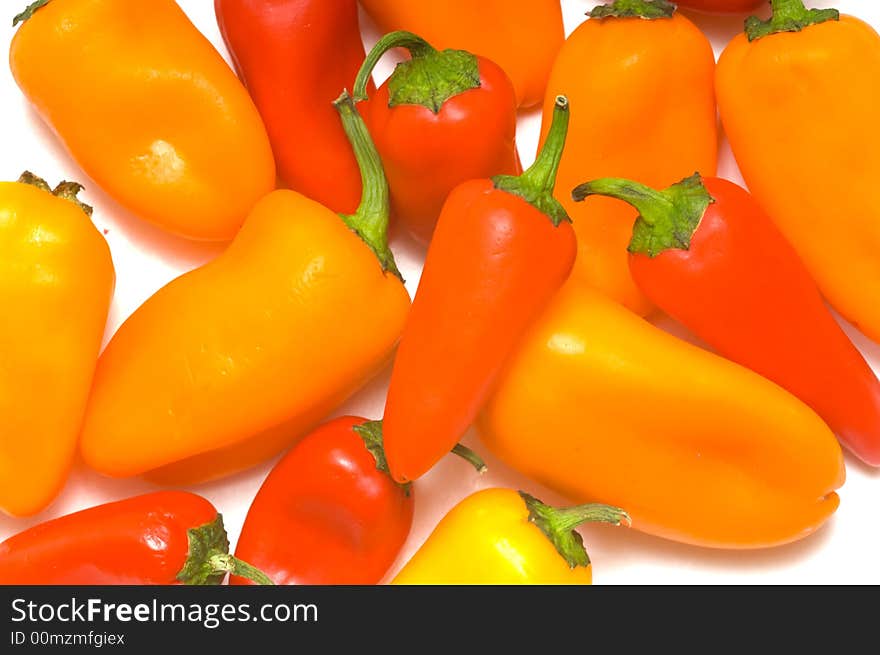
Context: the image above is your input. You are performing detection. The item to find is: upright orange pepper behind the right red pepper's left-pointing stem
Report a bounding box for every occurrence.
[542,0,718,314]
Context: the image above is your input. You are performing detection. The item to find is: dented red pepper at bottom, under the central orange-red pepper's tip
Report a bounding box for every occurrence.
[230,416,485,585]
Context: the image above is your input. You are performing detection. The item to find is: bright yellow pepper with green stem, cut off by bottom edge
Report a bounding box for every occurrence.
[392,489,629,585]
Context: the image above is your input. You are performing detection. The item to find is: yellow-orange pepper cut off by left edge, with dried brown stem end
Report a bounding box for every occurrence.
[0,173,116,516]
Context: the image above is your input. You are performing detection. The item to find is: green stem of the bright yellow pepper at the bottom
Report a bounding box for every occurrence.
[519,491,630,568]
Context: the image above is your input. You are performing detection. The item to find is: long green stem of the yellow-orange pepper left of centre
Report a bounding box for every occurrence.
[333,91,403,282]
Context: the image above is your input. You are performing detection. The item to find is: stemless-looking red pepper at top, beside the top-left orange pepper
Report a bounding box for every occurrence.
[214,0,372,213]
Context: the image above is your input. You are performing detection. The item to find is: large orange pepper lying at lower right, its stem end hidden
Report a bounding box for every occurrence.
[478,280,844,548]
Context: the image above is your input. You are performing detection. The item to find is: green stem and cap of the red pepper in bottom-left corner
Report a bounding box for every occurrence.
[177,514,275,585]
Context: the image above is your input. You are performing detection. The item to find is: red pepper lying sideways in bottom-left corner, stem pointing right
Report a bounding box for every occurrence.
[0,491,272,585]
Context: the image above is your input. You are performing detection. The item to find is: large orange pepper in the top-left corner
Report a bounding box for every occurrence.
[9,0,275,240]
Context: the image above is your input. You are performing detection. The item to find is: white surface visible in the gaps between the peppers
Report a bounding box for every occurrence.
[0,0,880,584]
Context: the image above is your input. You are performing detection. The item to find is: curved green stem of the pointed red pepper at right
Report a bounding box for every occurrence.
[571,173,715,257]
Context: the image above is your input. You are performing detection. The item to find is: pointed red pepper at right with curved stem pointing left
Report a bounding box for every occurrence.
[572,175,880,466]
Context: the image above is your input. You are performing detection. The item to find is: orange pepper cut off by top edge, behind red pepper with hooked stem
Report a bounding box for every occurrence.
[361,0,565,107]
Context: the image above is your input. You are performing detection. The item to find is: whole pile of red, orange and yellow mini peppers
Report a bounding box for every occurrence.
[0,0,880,585]
